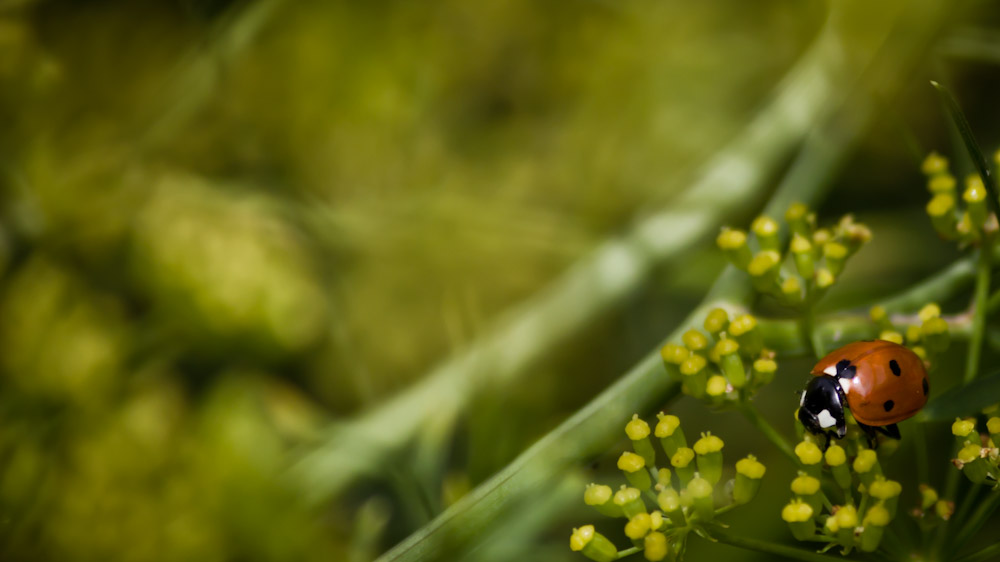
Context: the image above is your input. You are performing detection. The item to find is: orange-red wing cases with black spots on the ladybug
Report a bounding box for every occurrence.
[812,340,928,426]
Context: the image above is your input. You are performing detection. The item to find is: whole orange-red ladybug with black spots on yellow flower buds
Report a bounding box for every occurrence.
[798,340,929,447]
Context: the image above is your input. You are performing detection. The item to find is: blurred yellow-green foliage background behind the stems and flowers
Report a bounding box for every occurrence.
[0,0,1000,562]
